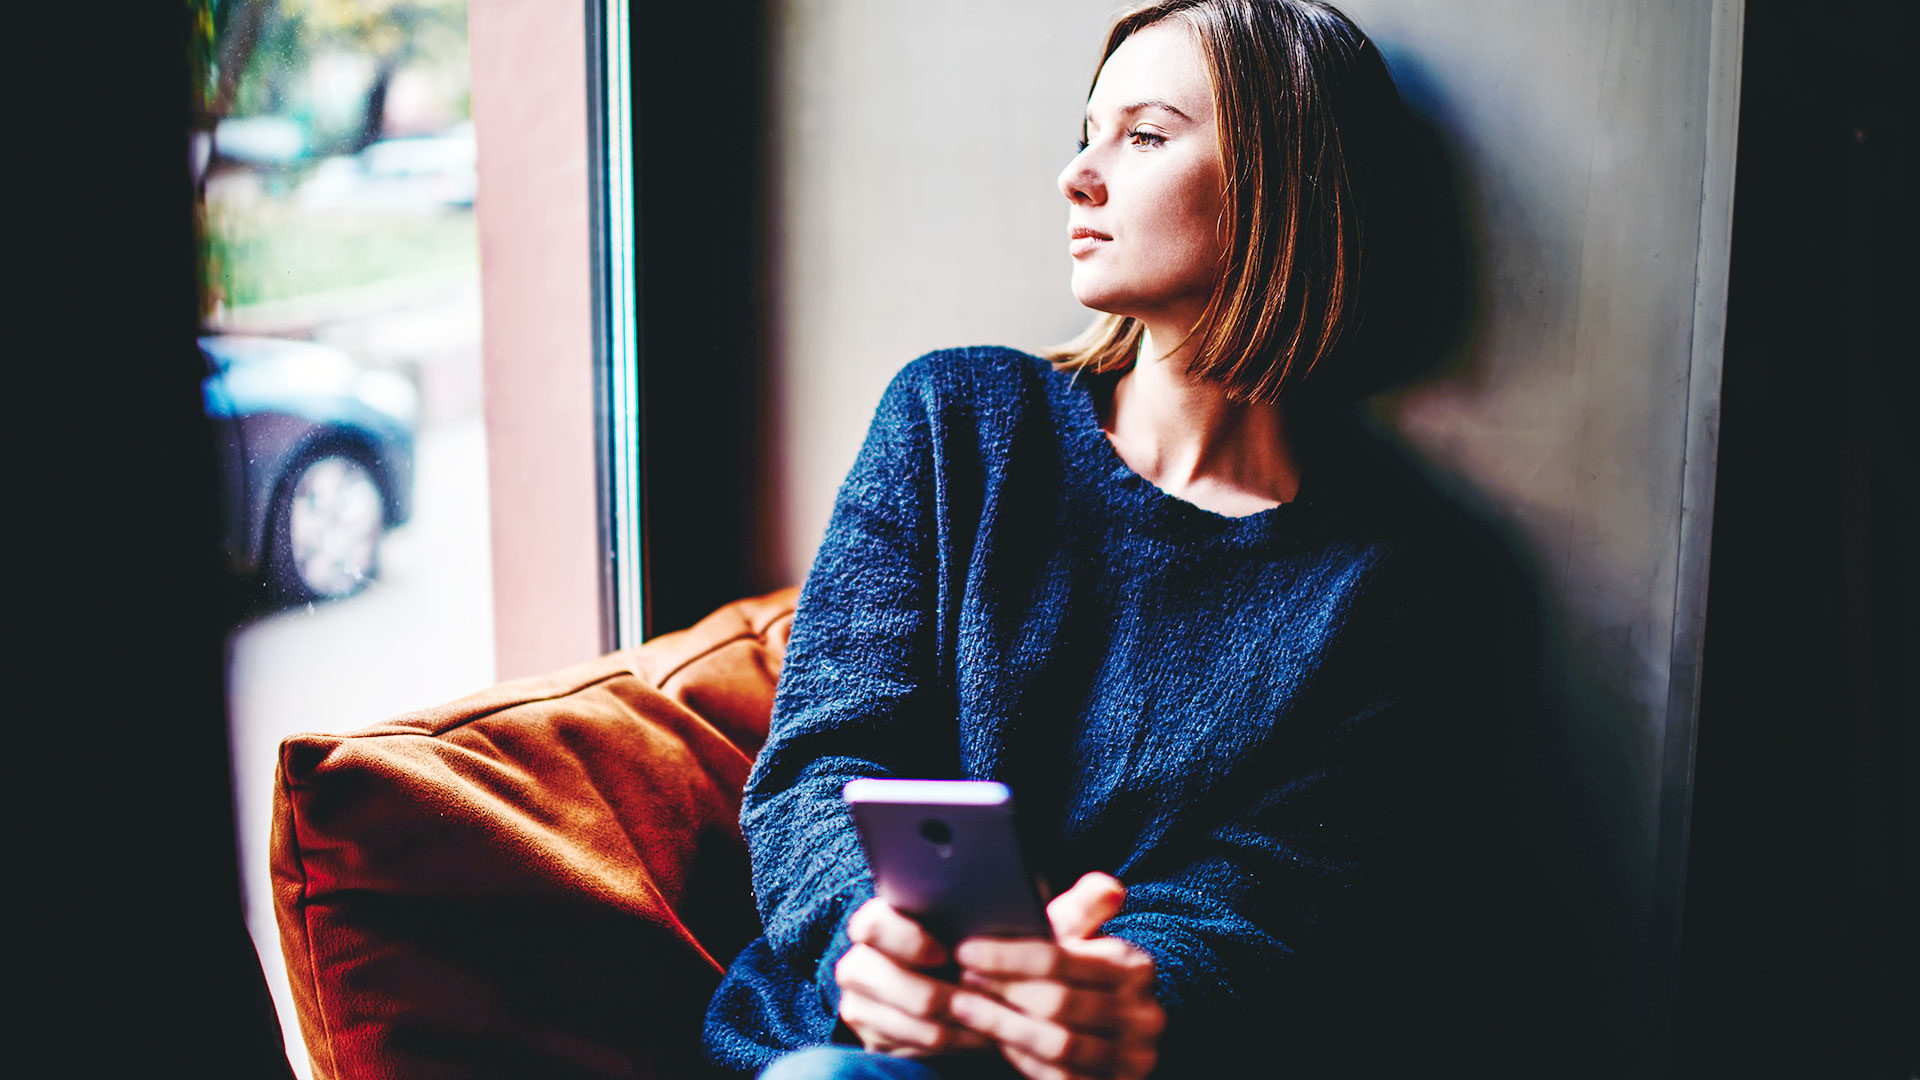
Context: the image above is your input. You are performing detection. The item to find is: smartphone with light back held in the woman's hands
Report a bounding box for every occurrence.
[841,778,1054,945]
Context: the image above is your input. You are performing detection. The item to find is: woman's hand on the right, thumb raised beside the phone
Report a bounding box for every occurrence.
[948,874,1167,1080]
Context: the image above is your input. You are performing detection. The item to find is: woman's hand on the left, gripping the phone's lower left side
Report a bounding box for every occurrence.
[833,897,991,1057]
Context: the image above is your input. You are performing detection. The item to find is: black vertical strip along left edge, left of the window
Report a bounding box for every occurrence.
[25,0,290,1076]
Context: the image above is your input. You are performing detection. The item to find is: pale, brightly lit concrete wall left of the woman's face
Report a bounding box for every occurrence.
[758,0,1114,582]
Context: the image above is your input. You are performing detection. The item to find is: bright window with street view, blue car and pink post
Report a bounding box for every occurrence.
[192,0,622,1074]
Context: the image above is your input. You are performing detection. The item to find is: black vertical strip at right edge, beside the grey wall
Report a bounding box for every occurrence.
[1676,2,1920,1080]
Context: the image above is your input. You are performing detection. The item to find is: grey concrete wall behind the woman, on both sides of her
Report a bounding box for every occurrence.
[762,0,1741,1038]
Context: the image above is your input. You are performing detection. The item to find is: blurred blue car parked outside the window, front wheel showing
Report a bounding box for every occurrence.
[200,334,420,601]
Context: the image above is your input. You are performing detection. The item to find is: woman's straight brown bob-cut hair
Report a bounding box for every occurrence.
[1046,0,1404,404]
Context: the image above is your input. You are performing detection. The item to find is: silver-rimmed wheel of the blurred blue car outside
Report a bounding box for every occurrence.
[267,450,386,600]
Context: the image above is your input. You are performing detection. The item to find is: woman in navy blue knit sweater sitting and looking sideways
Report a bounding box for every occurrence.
[707,0,1505,1078]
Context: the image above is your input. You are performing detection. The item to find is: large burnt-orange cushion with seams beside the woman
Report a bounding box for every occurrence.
[273,588,795,1080]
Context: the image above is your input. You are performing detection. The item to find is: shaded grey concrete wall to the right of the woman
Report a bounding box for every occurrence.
[1346,0,1743,1055]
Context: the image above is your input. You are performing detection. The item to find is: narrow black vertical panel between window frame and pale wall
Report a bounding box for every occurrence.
[632,0,775,636]
